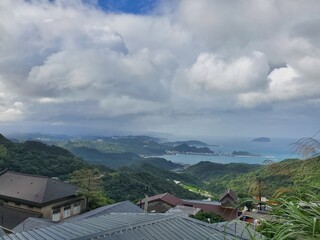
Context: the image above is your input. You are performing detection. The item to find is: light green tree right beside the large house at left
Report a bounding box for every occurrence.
[70,168,113,210]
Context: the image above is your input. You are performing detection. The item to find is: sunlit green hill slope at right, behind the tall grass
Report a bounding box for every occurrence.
[207,157,320,197]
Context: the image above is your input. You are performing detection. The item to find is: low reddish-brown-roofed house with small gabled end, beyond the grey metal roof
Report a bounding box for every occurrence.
[138,189,238,220]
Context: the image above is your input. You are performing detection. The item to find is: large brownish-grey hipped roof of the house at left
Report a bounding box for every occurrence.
[0,171,77,205]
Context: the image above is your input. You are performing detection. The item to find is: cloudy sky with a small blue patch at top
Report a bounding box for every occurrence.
[0,0,320,138]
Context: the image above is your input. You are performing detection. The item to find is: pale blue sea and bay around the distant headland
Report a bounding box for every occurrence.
[162,138,301,165]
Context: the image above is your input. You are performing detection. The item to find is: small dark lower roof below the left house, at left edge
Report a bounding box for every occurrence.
[0,206,41,229]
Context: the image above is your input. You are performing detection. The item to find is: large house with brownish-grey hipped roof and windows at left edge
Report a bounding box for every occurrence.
[0,171,86,229]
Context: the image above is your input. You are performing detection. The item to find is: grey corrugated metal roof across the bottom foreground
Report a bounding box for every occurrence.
[0,213,262,240]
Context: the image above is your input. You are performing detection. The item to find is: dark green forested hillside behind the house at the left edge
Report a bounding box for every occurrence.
[0,134,88,178]
